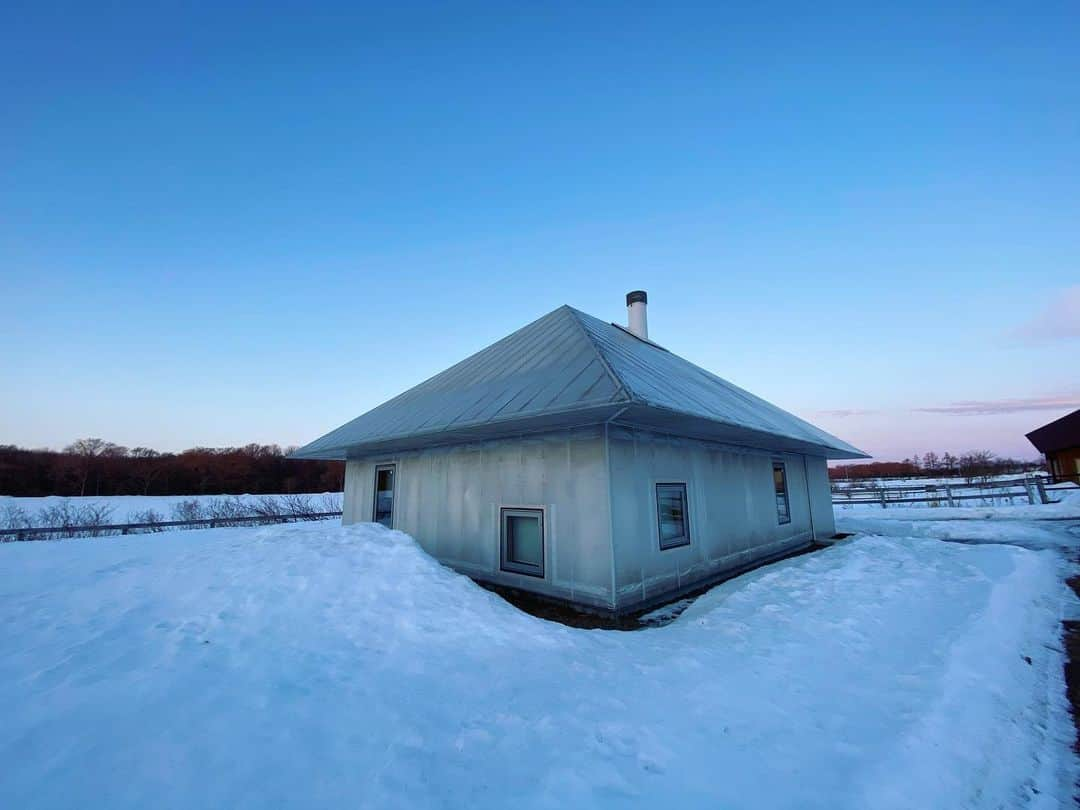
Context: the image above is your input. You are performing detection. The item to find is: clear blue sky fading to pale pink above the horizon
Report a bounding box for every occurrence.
[0,2,1080,459]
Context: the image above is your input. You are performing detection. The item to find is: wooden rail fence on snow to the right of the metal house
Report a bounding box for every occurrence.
[833,475,1076,509]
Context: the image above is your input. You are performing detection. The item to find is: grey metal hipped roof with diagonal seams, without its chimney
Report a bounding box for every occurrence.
[292,307,867,459]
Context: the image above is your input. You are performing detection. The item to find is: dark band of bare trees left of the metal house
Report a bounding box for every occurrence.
[0,438,345,496]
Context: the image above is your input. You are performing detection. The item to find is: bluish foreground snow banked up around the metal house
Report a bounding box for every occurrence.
[0,523,1076,808]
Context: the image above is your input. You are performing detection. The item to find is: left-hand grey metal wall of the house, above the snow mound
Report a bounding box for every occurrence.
[345,428,612,609]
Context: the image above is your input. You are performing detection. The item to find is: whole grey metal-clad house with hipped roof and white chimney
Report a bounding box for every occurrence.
[293,291,865,613]
